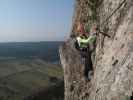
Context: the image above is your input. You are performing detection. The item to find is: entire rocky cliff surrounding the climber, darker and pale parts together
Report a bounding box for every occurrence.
[60,0,133,100]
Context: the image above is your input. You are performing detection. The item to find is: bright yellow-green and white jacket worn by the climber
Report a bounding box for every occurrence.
[76,36,96,48]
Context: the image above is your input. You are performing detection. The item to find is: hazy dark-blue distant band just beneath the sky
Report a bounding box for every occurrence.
[0,42,63,62]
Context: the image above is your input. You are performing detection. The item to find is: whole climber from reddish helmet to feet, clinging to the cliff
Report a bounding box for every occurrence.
[75,20,96,80]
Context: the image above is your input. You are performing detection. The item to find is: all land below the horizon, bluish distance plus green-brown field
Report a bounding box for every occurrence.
[0,43,64,100]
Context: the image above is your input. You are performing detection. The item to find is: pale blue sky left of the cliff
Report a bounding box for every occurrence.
[0,0,74,42]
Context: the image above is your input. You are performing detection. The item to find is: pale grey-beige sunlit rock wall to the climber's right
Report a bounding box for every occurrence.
[89,0,133,100]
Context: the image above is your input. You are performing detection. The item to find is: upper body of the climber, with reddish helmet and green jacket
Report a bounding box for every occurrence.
[75,20,97,54]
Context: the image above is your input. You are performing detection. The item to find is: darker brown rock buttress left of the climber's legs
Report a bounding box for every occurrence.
[60,40,90,100]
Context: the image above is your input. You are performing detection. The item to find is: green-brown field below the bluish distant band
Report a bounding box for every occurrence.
[0,59,64,100]
